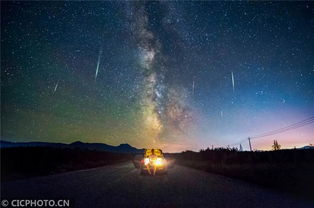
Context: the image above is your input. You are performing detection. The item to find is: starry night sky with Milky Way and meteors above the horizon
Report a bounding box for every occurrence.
[1,2,314,151]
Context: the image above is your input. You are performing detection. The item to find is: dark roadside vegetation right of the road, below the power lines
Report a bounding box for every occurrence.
[173,150,314,201]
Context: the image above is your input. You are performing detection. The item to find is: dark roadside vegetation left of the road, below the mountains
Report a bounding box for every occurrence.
[1,147,133,181]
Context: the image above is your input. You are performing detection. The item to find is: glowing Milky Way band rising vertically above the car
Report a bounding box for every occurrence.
[131,2,194,147]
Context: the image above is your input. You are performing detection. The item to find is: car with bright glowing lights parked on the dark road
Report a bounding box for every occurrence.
[140,149,167,175]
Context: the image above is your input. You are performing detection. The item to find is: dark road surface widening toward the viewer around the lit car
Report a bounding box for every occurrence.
[1,163,314,208]
